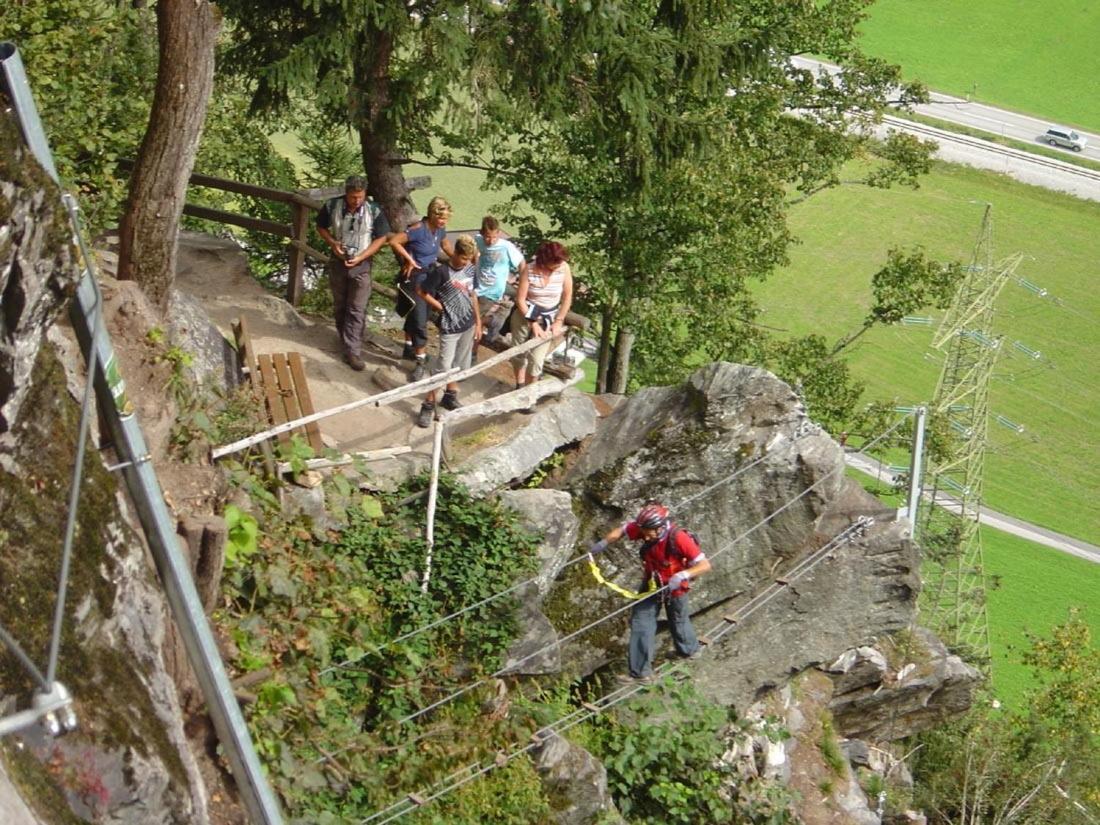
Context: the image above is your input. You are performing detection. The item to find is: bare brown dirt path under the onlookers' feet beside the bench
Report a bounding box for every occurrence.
[176,232,521,466]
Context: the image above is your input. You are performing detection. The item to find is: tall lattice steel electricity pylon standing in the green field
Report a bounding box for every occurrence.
[919,205,1023,667]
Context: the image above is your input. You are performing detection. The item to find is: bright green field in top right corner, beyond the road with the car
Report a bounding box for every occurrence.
[862,0,1100,131]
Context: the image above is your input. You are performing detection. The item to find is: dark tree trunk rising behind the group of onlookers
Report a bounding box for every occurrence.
[352,30,419,232]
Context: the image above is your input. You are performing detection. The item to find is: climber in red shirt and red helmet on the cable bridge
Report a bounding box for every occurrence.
[591,502,711,682]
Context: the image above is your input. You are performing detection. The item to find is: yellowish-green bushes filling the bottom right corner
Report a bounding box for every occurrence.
[913,616,1100,825]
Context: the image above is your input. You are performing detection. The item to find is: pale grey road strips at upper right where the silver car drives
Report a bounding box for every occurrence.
[792,57,1100,201]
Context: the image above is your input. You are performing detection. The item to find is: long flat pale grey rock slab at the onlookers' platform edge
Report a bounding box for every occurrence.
[458,389,596,495]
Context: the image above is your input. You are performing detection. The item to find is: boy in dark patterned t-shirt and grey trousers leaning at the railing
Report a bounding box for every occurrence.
[416,235,481,427]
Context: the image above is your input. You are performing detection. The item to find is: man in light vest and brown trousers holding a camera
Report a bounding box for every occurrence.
[317,175,389,372]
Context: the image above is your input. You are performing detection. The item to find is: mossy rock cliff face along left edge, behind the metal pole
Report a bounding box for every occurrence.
[0,112,208,824]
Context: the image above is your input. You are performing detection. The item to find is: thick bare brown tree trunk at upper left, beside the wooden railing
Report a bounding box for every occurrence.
[119,0,220,311]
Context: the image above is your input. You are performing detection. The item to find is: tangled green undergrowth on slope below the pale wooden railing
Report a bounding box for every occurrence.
[219,475,549,825]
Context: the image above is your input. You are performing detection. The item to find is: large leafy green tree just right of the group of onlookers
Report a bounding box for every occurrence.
[477,2,930,400]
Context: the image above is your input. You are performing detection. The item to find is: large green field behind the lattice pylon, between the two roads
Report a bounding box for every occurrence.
[756,164,1100,550]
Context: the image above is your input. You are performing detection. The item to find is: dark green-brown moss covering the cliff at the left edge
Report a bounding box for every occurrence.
[0,347,187,804]
